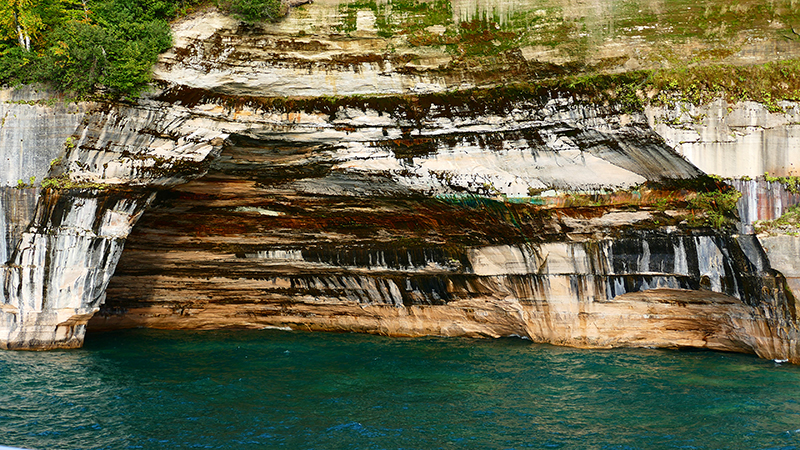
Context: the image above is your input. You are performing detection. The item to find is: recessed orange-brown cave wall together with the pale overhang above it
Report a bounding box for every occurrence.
[72,85,796,359]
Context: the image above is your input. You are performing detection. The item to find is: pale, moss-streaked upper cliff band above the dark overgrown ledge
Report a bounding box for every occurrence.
[155,0,800,97]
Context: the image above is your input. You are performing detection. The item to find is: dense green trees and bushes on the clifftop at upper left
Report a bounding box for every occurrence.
[0,0,280,97]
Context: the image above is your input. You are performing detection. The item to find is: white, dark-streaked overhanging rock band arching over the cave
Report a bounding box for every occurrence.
[60,89,700,193]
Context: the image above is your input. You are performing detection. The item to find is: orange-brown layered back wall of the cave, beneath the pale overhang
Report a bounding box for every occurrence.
[91,184,797,361]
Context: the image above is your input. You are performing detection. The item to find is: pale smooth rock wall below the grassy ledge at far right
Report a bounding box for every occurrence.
[645,99,800,233]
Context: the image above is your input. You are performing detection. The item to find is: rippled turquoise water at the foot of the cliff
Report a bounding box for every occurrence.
[0,330,800,449]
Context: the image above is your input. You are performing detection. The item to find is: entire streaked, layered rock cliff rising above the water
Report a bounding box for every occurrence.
[0,1,800,362]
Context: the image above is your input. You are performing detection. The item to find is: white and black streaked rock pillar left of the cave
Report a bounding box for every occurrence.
[0,89,221,349]
